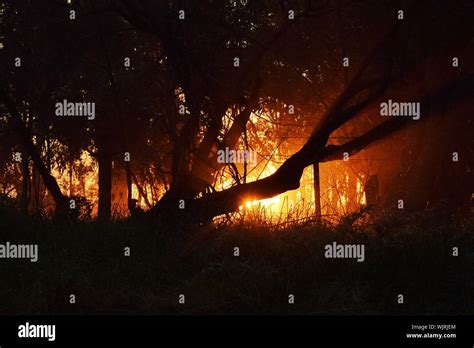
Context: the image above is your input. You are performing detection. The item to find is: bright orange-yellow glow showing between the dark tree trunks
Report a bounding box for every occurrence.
[32,113,367,221]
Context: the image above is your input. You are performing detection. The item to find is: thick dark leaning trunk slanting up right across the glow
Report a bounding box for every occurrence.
[149,74,474,222]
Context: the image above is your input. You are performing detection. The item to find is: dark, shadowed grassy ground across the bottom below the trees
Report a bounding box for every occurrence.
[0,207,474,315]
